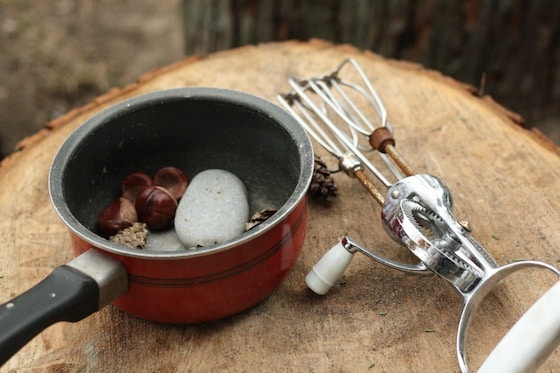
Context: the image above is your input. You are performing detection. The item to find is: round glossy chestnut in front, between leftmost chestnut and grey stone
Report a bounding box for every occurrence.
[135,185,177,230]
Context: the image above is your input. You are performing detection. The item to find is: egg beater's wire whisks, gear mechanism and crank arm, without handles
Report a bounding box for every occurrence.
[278,59,497,280]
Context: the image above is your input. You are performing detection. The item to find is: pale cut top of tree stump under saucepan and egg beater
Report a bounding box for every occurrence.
[0,40,560,372]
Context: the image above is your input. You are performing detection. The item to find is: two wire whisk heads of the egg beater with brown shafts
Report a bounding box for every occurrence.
[278,59,414,204]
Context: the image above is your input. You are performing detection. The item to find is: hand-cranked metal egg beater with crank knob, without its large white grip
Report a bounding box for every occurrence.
[277,59,560,372]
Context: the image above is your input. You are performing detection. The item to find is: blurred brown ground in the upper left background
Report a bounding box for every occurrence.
[0,0,560,159]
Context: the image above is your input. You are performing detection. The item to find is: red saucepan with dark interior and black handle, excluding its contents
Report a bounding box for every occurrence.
[0,88,313,364]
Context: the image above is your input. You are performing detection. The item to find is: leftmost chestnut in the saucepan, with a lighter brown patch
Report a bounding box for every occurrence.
[97,197,138,238]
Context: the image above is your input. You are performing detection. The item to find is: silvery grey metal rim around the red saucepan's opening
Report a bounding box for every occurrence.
[48,87,314,260]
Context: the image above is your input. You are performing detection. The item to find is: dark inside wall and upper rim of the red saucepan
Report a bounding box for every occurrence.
[50,88,313,253]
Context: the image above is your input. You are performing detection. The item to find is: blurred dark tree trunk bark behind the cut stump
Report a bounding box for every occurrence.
[183,0,560,125]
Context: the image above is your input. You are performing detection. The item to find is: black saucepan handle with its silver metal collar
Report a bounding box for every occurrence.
[0,249,128,366]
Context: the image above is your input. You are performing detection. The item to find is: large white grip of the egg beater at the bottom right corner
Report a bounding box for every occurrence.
[478,282,560,373]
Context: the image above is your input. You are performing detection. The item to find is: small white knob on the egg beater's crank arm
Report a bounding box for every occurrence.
[305,242,354,295]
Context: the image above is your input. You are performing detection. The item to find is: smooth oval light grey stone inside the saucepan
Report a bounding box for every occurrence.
[175,169,249,248]
